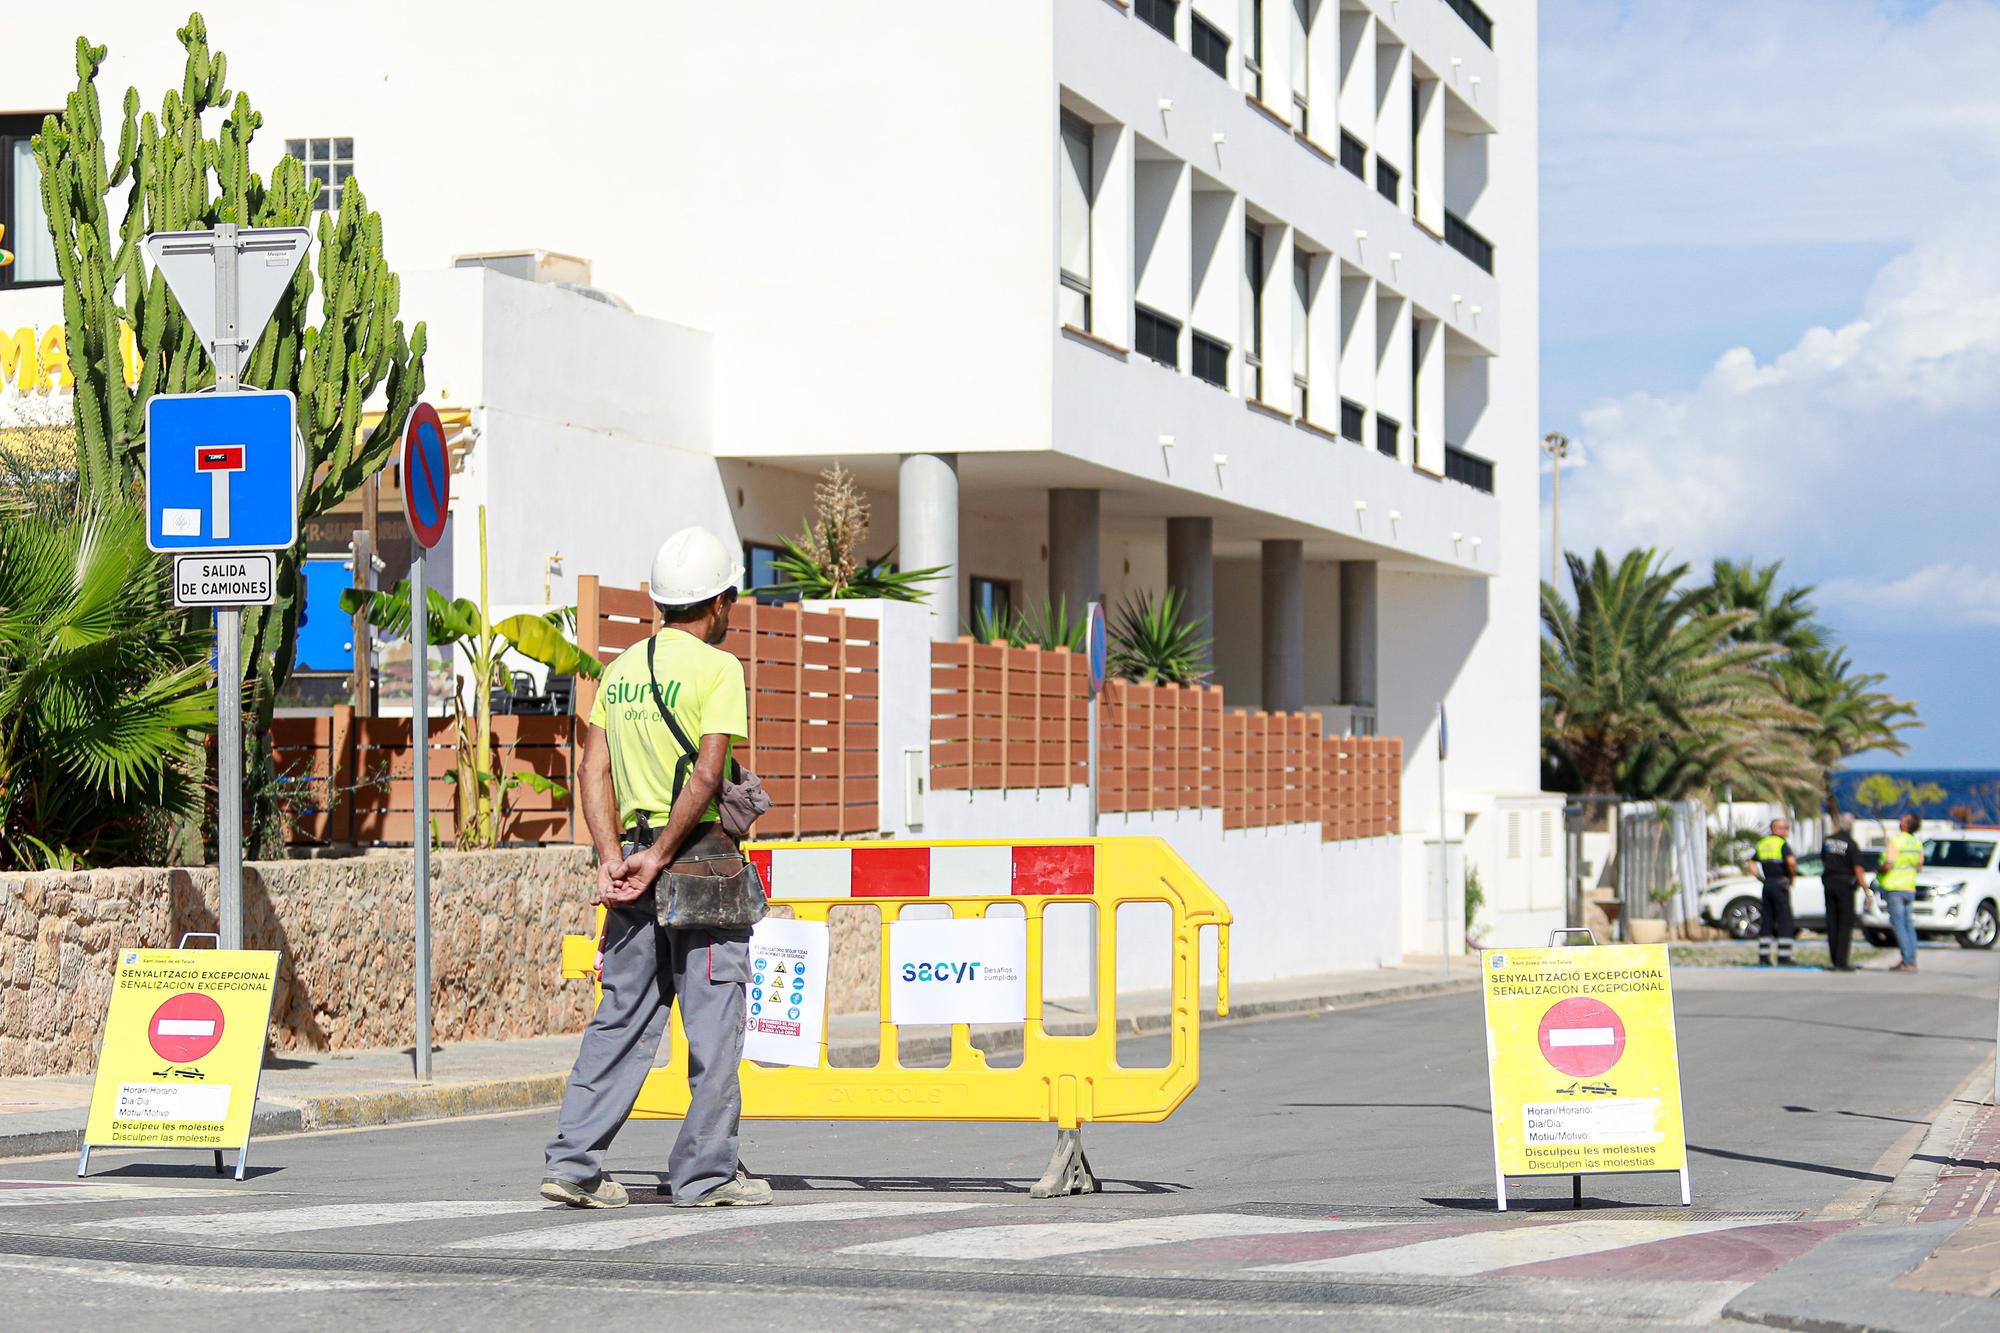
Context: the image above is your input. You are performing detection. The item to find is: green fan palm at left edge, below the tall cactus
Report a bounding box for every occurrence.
[0,486,216,869]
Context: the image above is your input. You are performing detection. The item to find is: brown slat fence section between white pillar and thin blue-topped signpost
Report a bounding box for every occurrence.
[930,638,1090,791]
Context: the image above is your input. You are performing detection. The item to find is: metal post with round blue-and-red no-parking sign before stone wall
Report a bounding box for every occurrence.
[402,402,452,1083]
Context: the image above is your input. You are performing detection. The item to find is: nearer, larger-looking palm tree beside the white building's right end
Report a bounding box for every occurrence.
[1542,550,1810,799]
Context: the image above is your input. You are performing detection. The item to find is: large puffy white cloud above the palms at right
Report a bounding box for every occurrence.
[1562,214,2000,600]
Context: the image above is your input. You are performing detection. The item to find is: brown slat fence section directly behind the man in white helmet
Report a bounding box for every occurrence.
[576,574,882,839]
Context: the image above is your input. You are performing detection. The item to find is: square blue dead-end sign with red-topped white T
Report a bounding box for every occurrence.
[146,390,302,552]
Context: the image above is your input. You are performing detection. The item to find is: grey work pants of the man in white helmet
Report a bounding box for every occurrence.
[548,893,750,1203]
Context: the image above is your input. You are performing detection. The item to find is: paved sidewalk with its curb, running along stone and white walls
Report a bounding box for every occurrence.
[0,957,1478,1159]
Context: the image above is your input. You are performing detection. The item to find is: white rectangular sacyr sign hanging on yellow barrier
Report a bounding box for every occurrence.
[888,917,1028,1023]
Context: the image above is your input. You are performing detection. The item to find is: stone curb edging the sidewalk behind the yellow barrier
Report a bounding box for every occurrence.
[0,973,1480,1159]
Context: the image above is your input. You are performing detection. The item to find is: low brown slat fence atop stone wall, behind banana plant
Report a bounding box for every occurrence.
[270,705,580,847]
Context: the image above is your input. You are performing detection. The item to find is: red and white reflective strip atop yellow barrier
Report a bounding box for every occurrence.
[750,843,1098,899]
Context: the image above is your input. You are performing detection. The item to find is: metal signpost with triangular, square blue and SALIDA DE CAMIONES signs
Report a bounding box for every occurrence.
[146,222,312,949]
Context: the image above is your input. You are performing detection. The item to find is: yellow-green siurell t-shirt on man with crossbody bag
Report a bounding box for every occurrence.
[590,628,750,829]
